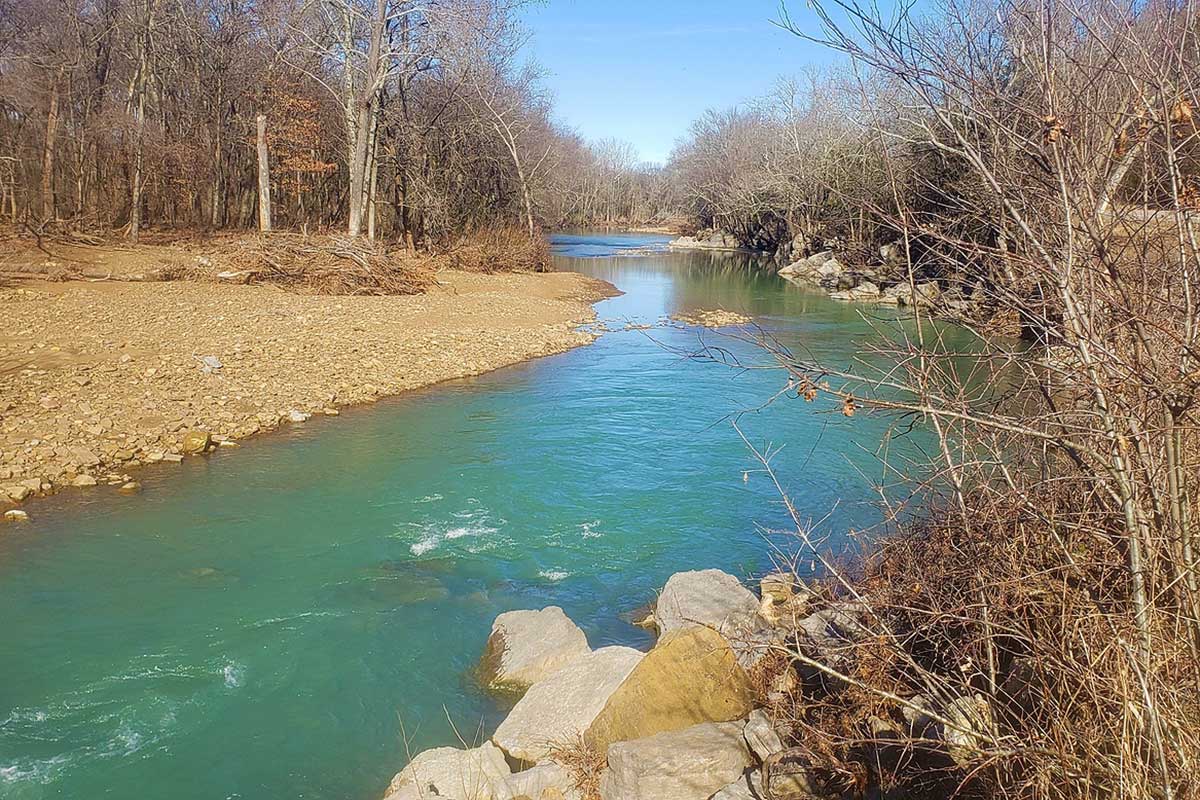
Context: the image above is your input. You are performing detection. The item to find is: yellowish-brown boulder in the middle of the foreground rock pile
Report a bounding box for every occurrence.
[584,627,754,758]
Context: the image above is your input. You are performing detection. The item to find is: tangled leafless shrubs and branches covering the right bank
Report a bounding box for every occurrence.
[677,0,1200,799]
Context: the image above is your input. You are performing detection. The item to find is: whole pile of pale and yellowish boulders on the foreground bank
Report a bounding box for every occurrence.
[385,570,988,800]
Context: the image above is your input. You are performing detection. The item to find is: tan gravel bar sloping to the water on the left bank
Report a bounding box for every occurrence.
[0,267,608,506]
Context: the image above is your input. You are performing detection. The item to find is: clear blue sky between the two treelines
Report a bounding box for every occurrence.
[524,0,834,162]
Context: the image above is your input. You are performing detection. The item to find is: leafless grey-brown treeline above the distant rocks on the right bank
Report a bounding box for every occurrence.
[667,17,1200,271]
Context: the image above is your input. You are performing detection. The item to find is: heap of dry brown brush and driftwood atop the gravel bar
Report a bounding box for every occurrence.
[212,234,433,295]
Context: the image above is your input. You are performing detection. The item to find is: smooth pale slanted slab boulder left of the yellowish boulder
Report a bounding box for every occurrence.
[492,648,643,764]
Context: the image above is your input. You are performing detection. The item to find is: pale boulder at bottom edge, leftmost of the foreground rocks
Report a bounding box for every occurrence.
[385,742,512,800]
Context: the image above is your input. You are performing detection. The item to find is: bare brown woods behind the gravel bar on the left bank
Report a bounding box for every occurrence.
[0,0,676,243]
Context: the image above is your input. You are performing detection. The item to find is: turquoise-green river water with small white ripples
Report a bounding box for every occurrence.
[0,236,916,800]
